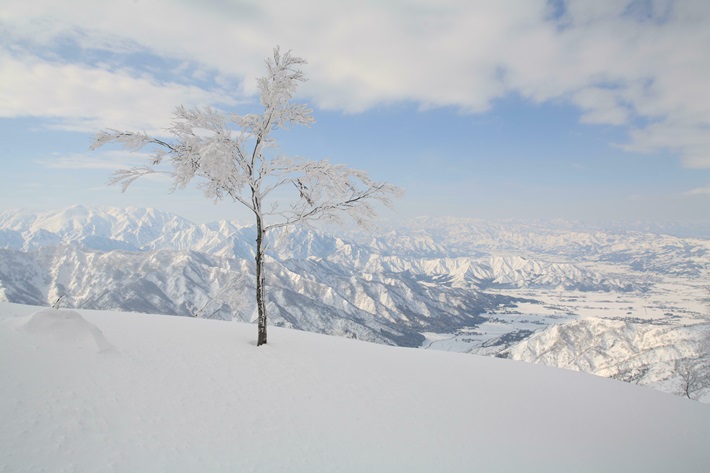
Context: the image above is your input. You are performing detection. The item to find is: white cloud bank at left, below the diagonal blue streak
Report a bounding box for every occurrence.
[0,53,239,133]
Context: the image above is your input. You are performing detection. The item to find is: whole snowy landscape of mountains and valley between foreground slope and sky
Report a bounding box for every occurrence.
[0,206,710,401]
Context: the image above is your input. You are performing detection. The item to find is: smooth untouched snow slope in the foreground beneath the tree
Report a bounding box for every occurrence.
[0,303,710,473]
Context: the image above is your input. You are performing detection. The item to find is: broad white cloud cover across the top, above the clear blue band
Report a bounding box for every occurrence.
[0,0,710,167]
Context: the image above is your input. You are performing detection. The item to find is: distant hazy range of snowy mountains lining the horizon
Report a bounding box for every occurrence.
[0,206,710,279]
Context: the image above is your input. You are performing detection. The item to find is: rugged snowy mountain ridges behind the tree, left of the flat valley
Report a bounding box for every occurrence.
[0,206,636,346]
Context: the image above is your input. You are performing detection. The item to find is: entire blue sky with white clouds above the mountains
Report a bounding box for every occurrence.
[0,0,710,222]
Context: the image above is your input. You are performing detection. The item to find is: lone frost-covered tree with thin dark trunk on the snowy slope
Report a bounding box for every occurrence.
[91,47,401,345]
